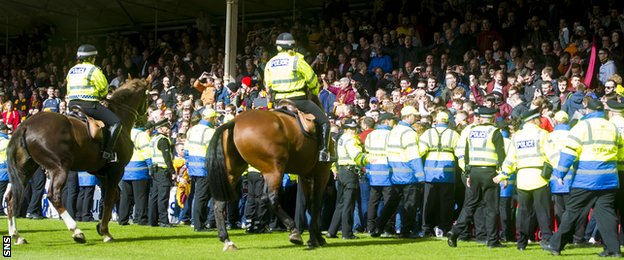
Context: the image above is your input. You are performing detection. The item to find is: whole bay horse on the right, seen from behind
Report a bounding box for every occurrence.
[207,110,331,251]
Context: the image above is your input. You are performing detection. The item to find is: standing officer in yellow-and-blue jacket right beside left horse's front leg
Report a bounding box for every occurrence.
[118,122,152,225]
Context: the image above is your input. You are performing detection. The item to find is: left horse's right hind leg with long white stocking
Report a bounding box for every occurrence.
[47,167,87,244]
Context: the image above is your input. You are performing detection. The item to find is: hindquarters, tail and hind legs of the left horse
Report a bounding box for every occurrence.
[7,112,104,243]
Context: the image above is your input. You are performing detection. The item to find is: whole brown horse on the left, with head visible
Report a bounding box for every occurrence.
[7,79,149,244]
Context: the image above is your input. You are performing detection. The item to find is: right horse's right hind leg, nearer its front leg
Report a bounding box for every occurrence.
[262,171,303,245]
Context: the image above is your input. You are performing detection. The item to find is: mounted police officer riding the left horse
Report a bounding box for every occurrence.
[67,44,122,161]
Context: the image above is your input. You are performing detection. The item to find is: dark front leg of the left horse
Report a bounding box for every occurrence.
[96,167,123,242]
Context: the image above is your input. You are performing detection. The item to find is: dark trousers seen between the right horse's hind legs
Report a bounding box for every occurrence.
[245,172,270,229]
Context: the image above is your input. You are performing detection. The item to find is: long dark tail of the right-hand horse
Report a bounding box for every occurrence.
[207,120,236,201]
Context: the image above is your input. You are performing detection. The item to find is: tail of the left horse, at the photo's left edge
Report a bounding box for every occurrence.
[7,125,30,215]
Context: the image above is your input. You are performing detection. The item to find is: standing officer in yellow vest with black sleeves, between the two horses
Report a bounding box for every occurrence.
[148,124,175,227]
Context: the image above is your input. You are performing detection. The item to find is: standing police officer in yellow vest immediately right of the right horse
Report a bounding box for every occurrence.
[327,119,368,239]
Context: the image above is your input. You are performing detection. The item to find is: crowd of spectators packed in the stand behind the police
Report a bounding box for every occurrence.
[0,0,624,240]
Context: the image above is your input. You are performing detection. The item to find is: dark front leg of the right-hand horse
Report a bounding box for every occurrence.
[306,163,330,246]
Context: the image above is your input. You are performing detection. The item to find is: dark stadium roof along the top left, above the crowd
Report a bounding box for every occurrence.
[0,0,365,36]
